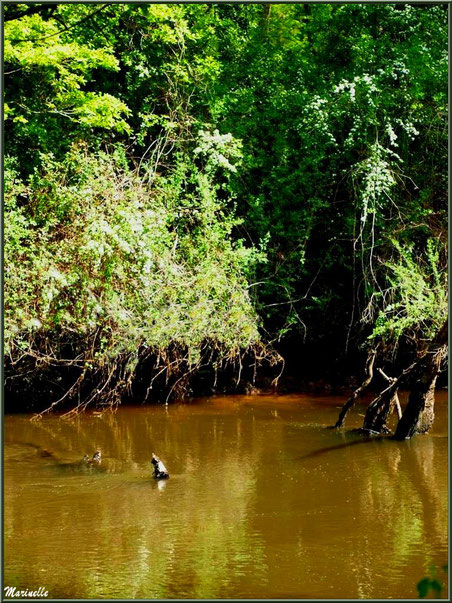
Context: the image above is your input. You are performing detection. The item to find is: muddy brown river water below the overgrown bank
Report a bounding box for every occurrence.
[4,392,448,599]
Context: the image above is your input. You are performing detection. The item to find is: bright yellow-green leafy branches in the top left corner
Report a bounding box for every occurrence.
[4,9,130,169]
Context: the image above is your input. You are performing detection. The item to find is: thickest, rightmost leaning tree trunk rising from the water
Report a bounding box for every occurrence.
[394,320,448,440]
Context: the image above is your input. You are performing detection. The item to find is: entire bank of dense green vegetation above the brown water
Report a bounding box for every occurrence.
[4,3,448,431]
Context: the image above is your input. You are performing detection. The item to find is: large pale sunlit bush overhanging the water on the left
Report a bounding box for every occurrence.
[5,148,259,370]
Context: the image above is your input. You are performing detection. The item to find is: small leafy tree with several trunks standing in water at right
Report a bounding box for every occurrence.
[335,239,448,439]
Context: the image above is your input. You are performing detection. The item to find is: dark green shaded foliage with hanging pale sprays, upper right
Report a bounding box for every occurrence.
[185,5,447,344]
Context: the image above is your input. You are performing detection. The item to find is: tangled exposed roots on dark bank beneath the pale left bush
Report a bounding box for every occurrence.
[7,331,284,420]
